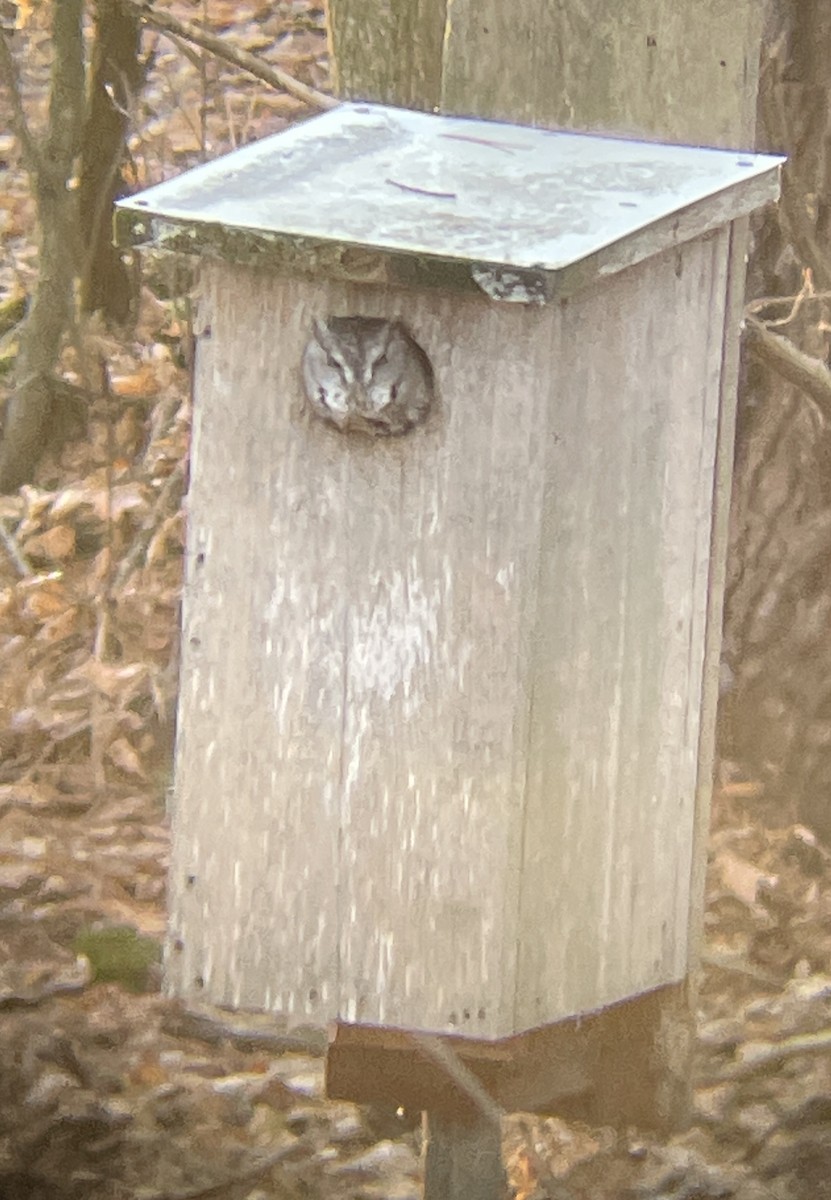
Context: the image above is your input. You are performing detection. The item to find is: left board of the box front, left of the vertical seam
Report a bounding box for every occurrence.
[169,269,346,1024]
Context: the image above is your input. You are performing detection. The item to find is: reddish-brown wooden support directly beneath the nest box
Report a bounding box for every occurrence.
[327,984,692,1130]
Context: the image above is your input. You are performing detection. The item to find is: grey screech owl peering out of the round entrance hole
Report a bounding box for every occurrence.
[303,317,435,437]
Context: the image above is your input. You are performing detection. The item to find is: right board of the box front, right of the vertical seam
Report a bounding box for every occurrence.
[333,292,546,1036]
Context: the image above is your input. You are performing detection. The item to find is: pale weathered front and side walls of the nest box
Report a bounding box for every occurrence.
[169,233,727,1038]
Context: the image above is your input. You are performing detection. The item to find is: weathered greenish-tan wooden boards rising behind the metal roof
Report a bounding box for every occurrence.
[329,0,765,148]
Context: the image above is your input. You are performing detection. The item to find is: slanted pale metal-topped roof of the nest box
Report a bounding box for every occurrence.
[116,103,784,300]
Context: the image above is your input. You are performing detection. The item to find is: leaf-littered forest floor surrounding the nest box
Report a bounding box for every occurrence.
[0,0,831,1200]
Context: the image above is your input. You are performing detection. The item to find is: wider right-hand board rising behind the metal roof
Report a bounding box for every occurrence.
[441,0,765,149]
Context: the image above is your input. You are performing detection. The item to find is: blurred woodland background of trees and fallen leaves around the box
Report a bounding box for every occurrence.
[0,0,831,1200]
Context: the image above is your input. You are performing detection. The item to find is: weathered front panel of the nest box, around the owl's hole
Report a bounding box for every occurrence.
[171,269,552,1037]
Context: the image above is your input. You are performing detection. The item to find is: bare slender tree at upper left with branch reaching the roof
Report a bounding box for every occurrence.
[0,0,335,492]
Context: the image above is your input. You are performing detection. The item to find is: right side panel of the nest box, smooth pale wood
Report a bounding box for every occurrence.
[516,229,728,1028]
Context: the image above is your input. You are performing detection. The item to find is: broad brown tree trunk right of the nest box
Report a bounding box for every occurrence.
[721,0,831,838]
